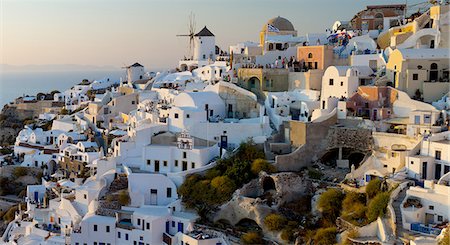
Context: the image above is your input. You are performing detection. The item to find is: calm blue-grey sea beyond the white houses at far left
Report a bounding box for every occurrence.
[0,70,124,109]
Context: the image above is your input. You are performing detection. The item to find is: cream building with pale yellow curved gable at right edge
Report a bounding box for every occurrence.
[386,49,450,102]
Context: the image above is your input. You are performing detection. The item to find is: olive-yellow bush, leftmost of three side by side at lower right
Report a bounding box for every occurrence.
[317,188,344,223]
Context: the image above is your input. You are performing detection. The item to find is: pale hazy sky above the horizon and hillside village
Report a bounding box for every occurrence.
[0,0,424,70]
